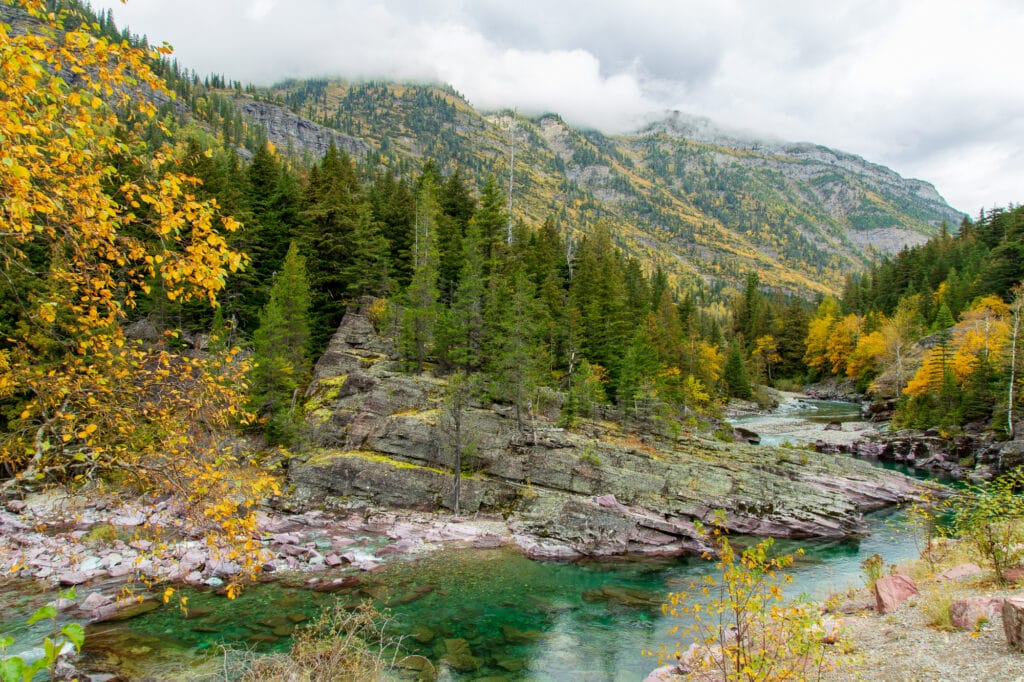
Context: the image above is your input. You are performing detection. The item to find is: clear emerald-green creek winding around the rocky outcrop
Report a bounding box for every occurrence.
[0,403,942,681]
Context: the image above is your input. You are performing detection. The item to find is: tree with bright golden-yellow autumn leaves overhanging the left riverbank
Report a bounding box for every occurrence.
[0,0,274,577]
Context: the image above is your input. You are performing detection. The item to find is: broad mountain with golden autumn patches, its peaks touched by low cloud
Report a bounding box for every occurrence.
[224,80,963,293]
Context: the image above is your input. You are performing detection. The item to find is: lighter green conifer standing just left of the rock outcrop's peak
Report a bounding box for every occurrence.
[251,243,310,444]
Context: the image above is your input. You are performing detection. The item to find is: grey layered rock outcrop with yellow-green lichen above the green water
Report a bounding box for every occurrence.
[290,311,915,558]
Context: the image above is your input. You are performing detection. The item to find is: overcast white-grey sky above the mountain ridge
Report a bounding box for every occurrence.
[93,0,1024,215]
